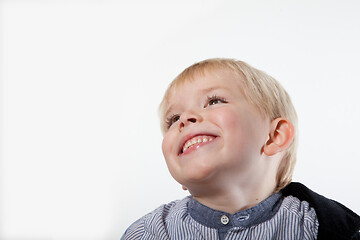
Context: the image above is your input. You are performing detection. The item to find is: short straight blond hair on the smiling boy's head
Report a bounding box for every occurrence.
[159,58,298,191]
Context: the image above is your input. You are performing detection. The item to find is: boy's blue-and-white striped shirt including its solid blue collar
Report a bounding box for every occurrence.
[121,193,319,240]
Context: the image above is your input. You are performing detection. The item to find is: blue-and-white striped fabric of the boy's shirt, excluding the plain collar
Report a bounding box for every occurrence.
[121,196,319,240]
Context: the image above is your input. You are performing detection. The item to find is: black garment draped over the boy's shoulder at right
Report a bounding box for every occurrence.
[281,182,360,239]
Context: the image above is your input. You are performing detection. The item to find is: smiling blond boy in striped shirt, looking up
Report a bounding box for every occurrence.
[122,59,360,240]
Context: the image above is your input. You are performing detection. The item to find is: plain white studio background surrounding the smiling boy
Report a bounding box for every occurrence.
[0,0,360,240]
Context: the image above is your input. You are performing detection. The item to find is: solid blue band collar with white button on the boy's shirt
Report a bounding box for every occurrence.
[188,192,282,230]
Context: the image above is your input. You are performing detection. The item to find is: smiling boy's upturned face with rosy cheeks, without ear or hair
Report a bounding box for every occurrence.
[162,70,270,191]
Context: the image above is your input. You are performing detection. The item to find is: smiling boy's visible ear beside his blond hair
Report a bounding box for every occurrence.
[264,118,295,156]
